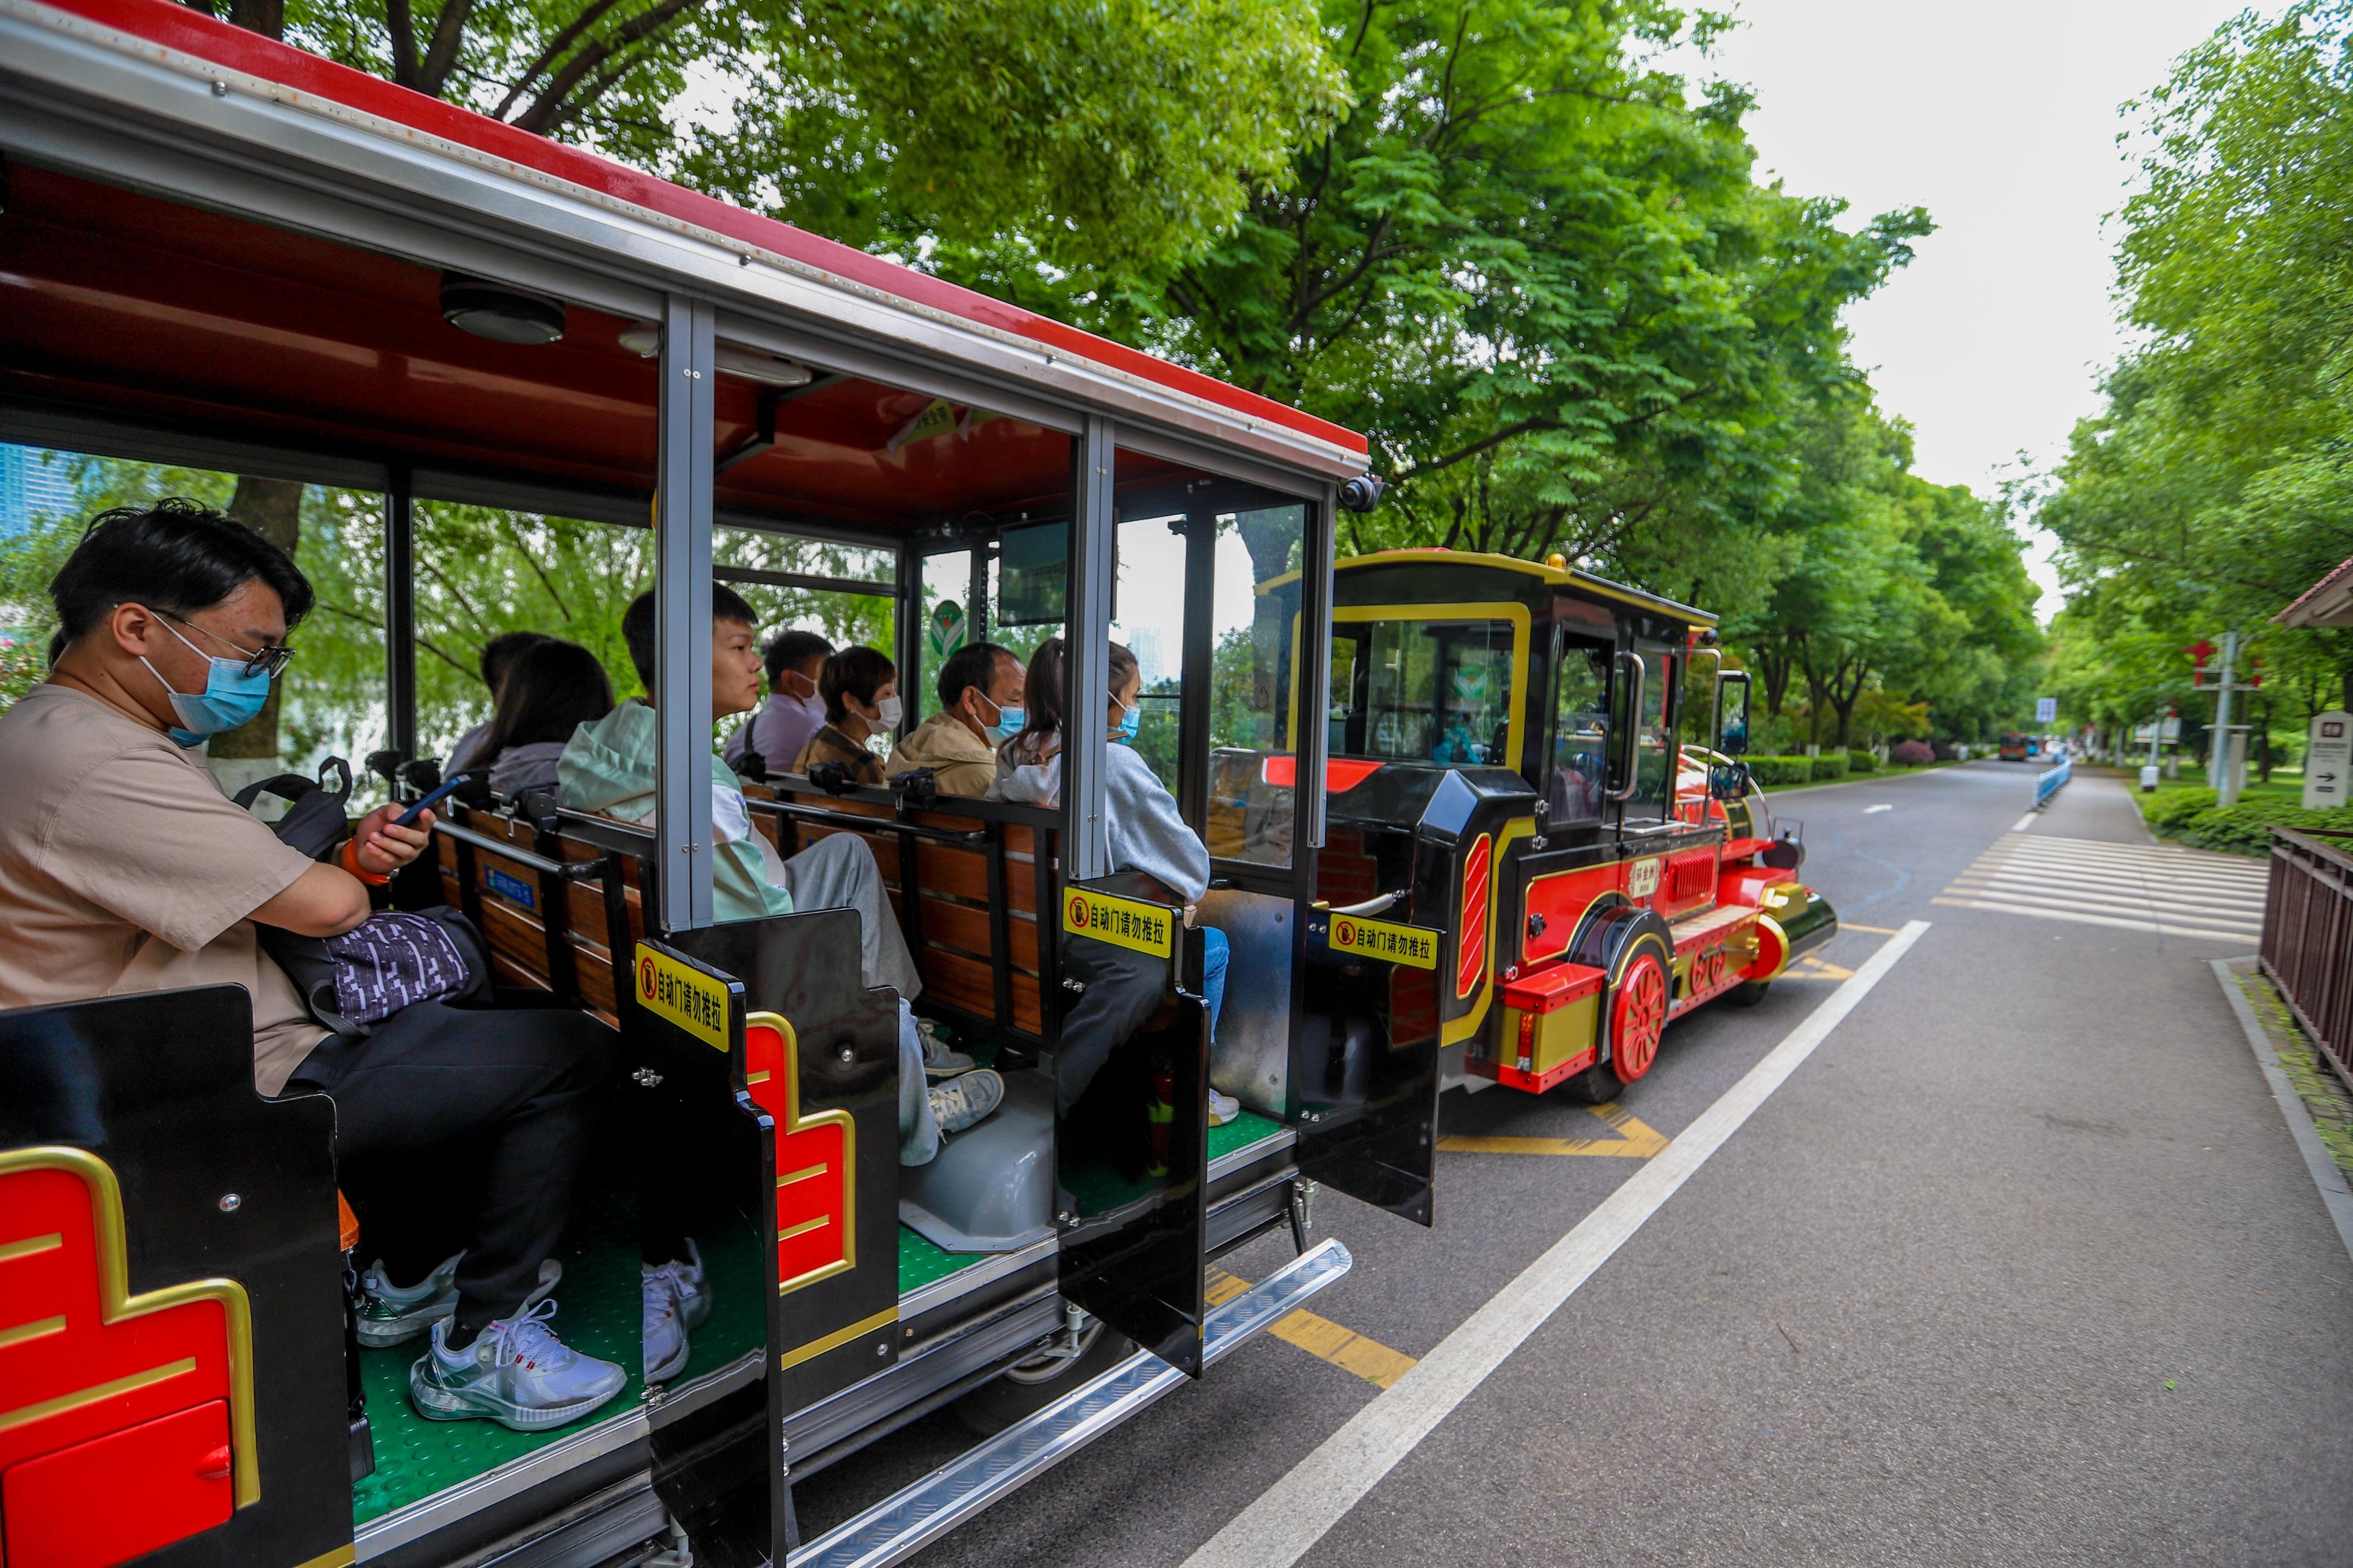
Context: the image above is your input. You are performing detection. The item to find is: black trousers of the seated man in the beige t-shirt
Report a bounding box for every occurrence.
[287,1001,619,1328]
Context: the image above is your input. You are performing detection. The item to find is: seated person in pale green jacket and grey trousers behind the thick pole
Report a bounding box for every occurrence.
[558,583,1005,1382]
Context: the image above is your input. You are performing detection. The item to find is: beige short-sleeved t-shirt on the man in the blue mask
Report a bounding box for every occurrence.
[0,684,327,1096]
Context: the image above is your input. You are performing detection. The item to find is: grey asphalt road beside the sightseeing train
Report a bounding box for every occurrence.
[795,764,2353,1568]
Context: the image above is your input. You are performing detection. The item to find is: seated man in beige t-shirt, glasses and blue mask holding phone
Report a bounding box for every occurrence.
[0,501,628,1429]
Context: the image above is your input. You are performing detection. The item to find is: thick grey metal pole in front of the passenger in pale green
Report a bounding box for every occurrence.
[652,294,717,931]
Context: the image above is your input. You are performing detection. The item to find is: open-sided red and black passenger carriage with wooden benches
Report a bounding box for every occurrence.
[0,0,1412,1568]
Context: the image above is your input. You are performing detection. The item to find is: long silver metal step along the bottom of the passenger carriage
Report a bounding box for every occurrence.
[786,1241,1355,1568]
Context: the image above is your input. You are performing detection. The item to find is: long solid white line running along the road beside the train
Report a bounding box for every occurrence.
[1186,919,1929,1568]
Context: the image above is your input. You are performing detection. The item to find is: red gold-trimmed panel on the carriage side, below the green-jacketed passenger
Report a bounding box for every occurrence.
[744,1013,859,1293]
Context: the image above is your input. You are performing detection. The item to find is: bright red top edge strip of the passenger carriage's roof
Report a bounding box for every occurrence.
[45,0,1370,454]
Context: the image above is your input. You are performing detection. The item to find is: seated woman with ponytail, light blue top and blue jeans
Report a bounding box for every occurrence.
[998,637,1243,1126]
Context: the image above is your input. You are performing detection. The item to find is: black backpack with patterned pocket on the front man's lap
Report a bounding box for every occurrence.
[236,757,490,1039]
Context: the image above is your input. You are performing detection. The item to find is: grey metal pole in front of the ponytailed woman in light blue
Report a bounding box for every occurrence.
[1068,414,1120,883]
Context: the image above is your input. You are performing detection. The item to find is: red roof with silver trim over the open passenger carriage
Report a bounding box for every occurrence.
[0,0,1367,533]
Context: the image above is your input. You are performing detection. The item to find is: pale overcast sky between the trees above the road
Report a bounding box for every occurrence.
[1704,0,2240,616]
